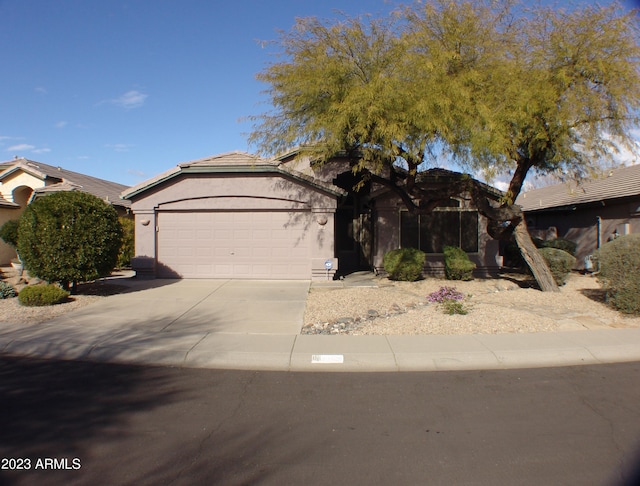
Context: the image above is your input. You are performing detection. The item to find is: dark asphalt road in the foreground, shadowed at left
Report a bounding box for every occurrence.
[0,357,640,486]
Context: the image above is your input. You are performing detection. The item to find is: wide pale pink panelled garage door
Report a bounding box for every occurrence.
[158,211,311,279]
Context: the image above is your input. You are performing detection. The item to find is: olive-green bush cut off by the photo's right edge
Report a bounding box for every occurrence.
[595,235,640,314]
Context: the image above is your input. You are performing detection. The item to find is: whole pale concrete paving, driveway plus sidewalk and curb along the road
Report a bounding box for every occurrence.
[0,276,640,372]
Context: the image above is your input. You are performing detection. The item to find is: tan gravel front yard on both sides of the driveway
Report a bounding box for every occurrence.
[0,269,640,335]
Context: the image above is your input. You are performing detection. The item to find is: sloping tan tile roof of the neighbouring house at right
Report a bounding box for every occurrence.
[516,165,640,211]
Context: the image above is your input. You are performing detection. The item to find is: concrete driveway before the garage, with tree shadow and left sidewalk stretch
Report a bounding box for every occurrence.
[0,279,310,367]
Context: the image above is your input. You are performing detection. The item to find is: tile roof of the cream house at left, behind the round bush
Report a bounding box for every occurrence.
[0,158,131,207]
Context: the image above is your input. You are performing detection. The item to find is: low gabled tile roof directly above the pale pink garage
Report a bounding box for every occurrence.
[120,151,343,199]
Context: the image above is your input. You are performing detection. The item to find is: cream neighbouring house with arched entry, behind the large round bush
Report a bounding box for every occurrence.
[0,158,131,264]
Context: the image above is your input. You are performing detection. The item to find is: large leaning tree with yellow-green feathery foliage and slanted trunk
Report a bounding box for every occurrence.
[251,0,640,290]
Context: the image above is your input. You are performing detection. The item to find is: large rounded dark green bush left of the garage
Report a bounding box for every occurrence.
[18,191,122,289]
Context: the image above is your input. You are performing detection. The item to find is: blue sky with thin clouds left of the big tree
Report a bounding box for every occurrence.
[0,0,639,186]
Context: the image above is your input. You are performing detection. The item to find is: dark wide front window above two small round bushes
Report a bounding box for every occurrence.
[400,200,478,253]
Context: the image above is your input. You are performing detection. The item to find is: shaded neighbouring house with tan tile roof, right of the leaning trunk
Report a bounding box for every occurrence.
[516,165,640,269]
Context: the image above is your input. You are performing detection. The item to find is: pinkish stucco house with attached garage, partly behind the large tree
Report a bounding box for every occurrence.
[122,152,501,279]
